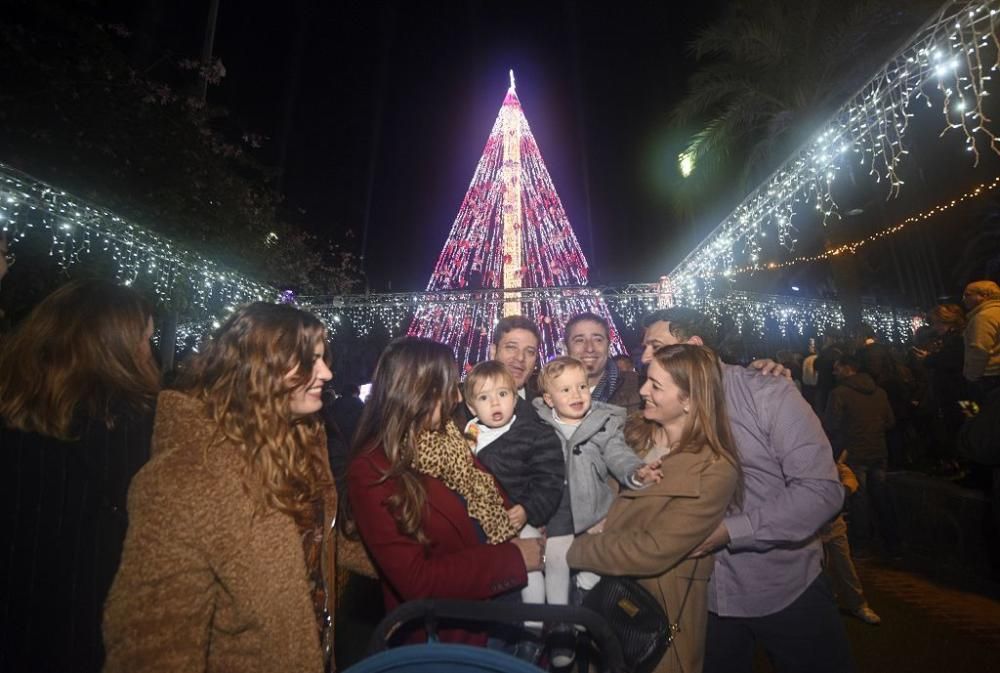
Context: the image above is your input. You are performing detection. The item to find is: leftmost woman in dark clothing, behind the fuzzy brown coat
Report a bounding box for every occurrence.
[0,281,159,673]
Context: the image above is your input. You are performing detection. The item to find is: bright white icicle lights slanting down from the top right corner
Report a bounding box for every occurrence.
[670,0,1000,297]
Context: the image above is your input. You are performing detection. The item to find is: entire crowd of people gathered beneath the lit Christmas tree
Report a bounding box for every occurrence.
[0,272,1000,673]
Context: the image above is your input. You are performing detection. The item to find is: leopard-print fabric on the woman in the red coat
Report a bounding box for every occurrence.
[414,421,517,544]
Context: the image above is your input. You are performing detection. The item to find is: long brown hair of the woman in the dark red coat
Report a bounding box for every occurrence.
[348,337,458,544]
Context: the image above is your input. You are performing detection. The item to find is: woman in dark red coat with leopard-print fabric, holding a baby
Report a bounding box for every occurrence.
[347,338,542,644]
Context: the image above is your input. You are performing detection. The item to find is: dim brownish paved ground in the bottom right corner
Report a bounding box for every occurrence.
[756,560,1000,673]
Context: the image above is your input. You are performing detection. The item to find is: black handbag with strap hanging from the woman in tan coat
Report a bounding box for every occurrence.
[583,562,698,673]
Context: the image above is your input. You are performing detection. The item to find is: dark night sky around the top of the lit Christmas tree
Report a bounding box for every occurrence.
[182,0,725,290]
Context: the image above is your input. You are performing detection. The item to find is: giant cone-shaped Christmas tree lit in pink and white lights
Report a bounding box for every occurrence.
[408,71,625,365]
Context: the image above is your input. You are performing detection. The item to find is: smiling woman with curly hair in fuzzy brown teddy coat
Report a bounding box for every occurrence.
[104,303,337,673]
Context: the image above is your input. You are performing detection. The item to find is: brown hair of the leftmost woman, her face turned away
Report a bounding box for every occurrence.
[0,280,160,440]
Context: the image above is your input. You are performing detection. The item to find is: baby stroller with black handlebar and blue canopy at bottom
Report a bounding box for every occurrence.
[345,600,626,673]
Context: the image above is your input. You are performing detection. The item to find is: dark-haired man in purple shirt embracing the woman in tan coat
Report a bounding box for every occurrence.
[642,307,855,673]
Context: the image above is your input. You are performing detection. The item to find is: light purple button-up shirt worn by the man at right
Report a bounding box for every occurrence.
[708,365,844,617]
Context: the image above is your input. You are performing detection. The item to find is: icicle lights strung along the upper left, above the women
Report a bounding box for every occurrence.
[0,164,278,314]
